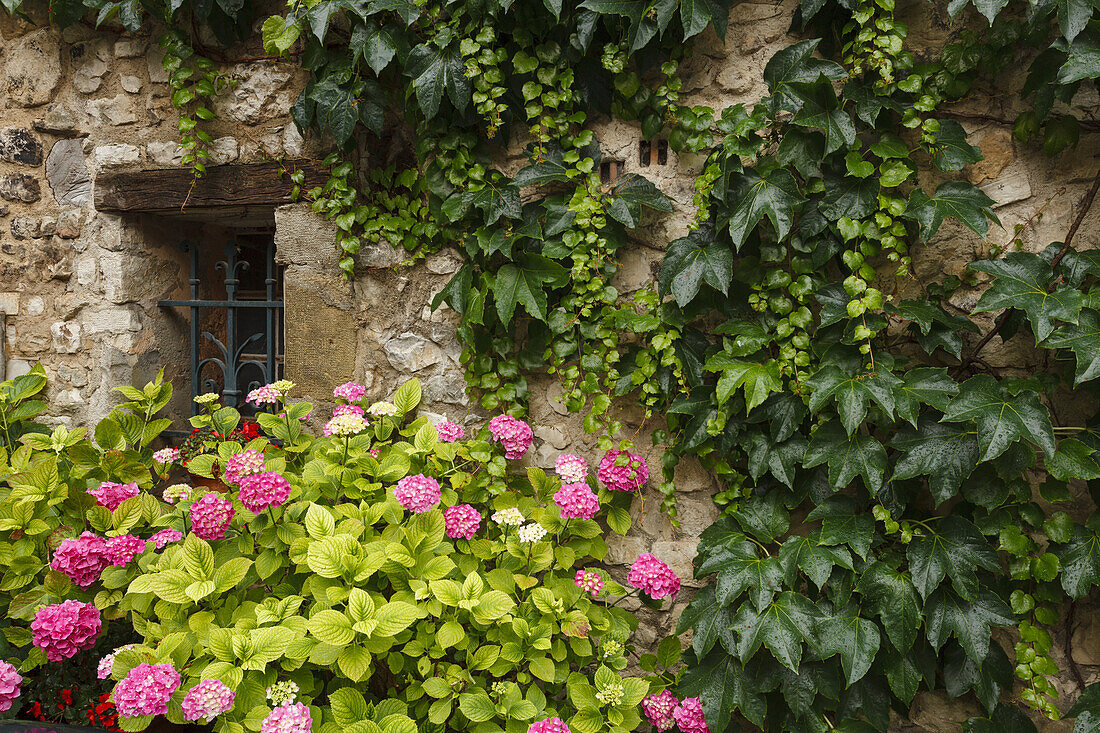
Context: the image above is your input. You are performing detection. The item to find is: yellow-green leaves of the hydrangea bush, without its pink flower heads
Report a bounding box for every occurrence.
[0,369,680,733]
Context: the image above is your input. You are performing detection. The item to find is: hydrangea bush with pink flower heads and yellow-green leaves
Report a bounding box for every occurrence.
[0,372,705,733]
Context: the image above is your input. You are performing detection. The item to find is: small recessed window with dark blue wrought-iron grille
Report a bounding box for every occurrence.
[160,228,283,415]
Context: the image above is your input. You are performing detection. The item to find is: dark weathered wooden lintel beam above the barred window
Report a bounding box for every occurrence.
[95,160,329,212]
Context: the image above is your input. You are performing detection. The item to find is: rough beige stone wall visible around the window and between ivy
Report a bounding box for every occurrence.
[0,0,1100,733]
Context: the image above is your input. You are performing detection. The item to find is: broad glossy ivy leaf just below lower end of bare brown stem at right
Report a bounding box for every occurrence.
[944,374,1056,461]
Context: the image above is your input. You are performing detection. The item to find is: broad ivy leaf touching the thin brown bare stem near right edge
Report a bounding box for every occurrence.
[970,252,1085,341]
